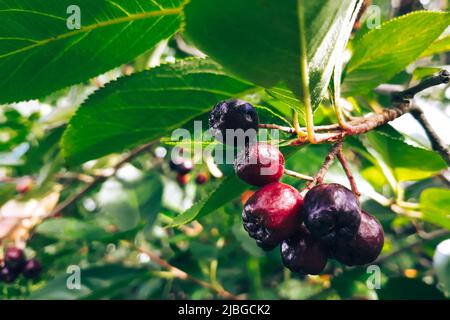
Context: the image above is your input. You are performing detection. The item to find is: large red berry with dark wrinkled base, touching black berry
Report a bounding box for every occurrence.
[242,182,303,250]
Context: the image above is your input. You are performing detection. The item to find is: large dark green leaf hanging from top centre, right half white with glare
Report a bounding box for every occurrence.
[185,0,360,111]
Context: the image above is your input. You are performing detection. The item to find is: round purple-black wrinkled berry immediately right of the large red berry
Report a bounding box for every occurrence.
[303,183,361,245]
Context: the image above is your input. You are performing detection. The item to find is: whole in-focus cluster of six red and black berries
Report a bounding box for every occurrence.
[210,100,384,274]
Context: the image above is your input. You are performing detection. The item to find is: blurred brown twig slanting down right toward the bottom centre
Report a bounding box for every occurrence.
[134,245,240,300]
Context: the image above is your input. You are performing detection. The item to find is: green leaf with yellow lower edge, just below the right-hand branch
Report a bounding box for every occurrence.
[365,131,447,181]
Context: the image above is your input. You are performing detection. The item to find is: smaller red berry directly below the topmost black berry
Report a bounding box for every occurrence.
[234,143,284,187]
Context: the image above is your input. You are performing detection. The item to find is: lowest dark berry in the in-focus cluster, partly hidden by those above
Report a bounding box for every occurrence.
[281,226,328,274]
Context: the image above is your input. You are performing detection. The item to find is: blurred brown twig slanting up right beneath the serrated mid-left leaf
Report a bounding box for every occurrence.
[49,142,155,216]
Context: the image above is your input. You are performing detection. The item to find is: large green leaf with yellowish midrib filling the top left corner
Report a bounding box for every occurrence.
[0,0,183,102]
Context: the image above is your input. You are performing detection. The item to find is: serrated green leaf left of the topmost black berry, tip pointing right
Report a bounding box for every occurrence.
[62,59,253,164]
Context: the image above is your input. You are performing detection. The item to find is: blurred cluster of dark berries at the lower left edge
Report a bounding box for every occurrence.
[0,247,42,283]
